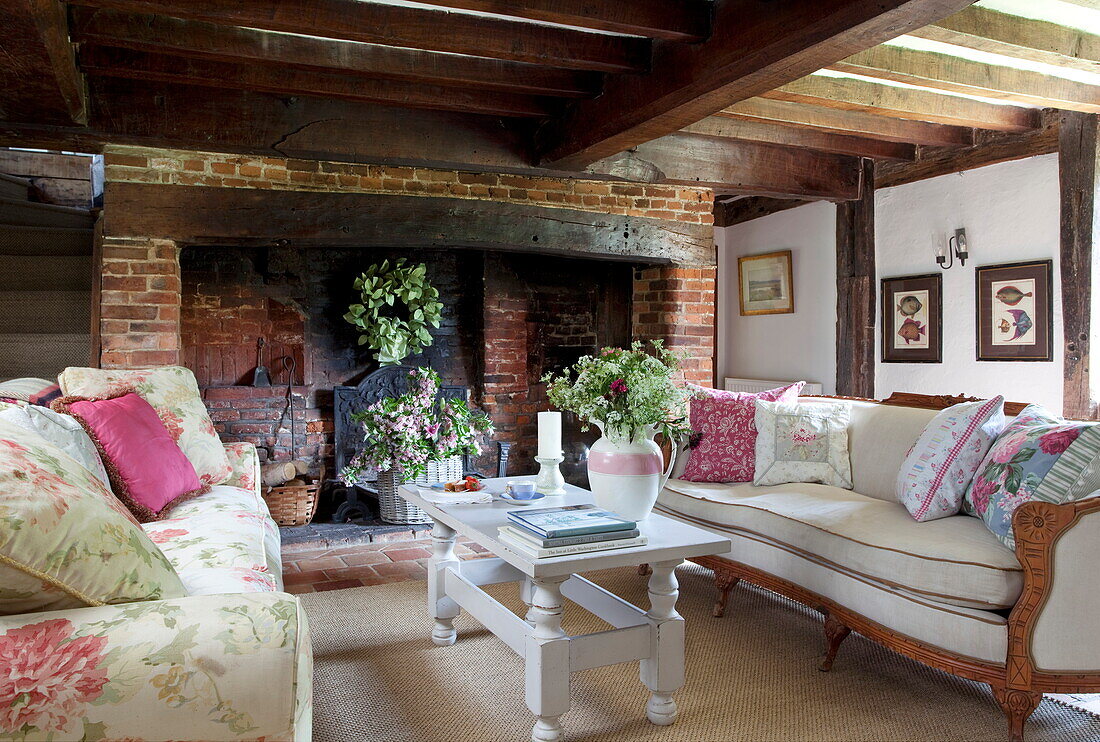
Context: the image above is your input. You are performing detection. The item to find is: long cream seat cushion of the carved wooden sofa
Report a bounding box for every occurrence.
[658,479,1023,610]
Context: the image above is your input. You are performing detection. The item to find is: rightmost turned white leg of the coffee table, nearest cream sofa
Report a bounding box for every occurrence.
[640,560,684,727]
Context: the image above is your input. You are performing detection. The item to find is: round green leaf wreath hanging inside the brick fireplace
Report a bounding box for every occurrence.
[344,257,443,366]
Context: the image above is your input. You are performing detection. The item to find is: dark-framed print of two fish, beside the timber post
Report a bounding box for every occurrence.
[881,273,944,363]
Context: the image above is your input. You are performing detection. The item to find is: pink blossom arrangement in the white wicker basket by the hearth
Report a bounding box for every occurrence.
[340,367,493,485]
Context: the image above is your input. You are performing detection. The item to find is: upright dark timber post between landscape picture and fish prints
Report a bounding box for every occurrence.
[836,159,876,398]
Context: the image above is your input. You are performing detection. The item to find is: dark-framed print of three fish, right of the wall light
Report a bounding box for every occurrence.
[975,261,1054,361]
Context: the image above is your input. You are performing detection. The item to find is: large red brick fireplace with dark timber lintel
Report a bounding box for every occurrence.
[98,147,716,473]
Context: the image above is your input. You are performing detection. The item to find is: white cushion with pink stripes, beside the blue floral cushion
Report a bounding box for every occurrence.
[895,397,1004,521]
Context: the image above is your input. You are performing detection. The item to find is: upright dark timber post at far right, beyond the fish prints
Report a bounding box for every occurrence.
[1058,112,1100,418]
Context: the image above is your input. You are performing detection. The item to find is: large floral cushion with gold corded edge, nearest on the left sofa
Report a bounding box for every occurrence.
[0,421,186,614]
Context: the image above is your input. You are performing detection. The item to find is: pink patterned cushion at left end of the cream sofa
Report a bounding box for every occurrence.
[681,381,805,481]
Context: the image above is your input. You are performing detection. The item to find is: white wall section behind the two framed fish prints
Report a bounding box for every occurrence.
[871,155,1063,412]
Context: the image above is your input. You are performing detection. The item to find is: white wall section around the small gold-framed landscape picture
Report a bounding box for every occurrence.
[715,203,836,394]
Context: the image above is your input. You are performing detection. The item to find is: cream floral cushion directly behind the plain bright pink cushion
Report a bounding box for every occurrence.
[57,366,232,485]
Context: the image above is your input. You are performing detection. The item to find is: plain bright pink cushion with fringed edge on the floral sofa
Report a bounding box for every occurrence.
[58,394,204,522]
